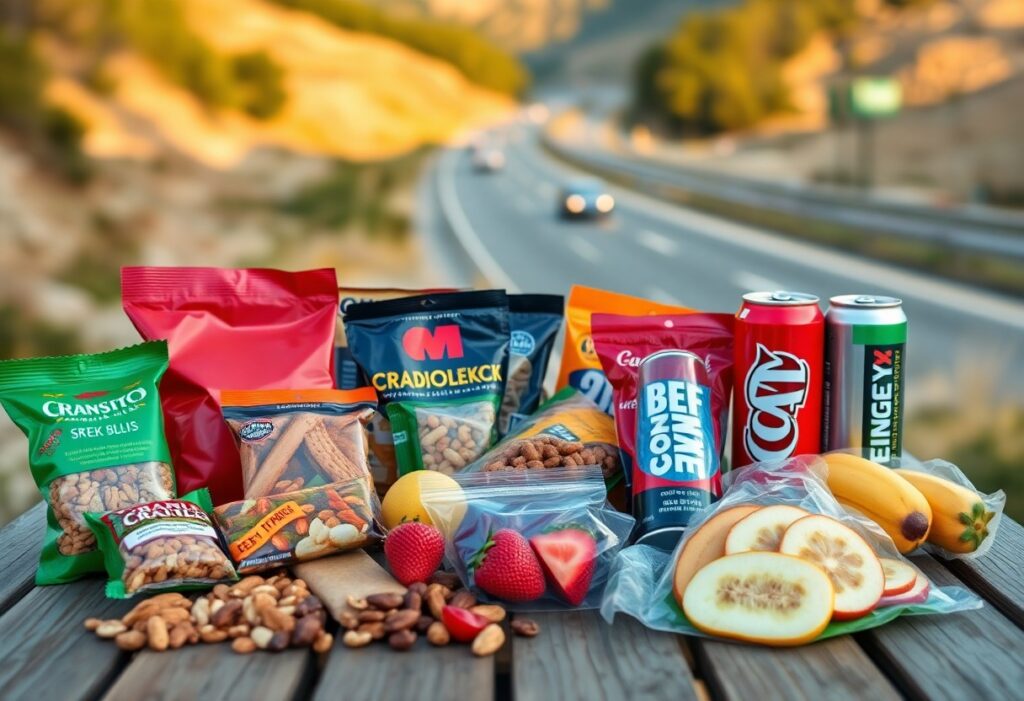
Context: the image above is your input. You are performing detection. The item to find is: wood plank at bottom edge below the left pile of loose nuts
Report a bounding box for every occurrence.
[103,643,313,701]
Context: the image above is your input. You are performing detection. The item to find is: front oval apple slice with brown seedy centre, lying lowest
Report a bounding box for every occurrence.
[683,552,835,645]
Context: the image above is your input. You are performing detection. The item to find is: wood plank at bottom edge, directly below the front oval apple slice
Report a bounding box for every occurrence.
[693,637,900,701]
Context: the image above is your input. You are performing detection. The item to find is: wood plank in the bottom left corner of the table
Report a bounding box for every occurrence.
[0,579,130,701]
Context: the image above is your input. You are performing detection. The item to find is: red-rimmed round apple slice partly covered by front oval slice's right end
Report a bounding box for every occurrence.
[778,515,886,620]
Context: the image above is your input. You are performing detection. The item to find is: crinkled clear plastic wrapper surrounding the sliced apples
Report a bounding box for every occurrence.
[601,455,982,642]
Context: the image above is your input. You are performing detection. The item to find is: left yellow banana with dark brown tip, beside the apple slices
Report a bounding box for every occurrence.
[822,452,932,554]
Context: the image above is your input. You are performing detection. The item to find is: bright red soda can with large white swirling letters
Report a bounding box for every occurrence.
[732,292,825,468]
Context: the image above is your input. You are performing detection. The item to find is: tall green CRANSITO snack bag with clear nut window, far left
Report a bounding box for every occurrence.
[0,341,175,584]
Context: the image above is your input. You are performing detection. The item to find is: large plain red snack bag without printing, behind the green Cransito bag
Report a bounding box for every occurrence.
[121,267,338,503]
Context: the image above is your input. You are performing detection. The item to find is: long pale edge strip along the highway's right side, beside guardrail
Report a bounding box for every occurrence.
[615,188,1024,330]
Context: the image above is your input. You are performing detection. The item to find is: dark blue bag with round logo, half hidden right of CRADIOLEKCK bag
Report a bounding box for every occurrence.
[498,295,565,436]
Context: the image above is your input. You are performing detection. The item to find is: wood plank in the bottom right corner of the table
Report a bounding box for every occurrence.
[858,557,1024,700]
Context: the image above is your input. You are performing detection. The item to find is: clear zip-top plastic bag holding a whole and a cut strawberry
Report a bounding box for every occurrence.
[421,466,635,611]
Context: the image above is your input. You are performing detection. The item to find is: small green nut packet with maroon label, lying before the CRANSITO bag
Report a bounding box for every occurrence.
[85,489,239,599]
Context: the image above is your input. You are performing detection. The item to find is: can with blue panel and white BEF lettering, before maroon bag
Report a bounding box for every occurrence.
[633,350,722,550]
